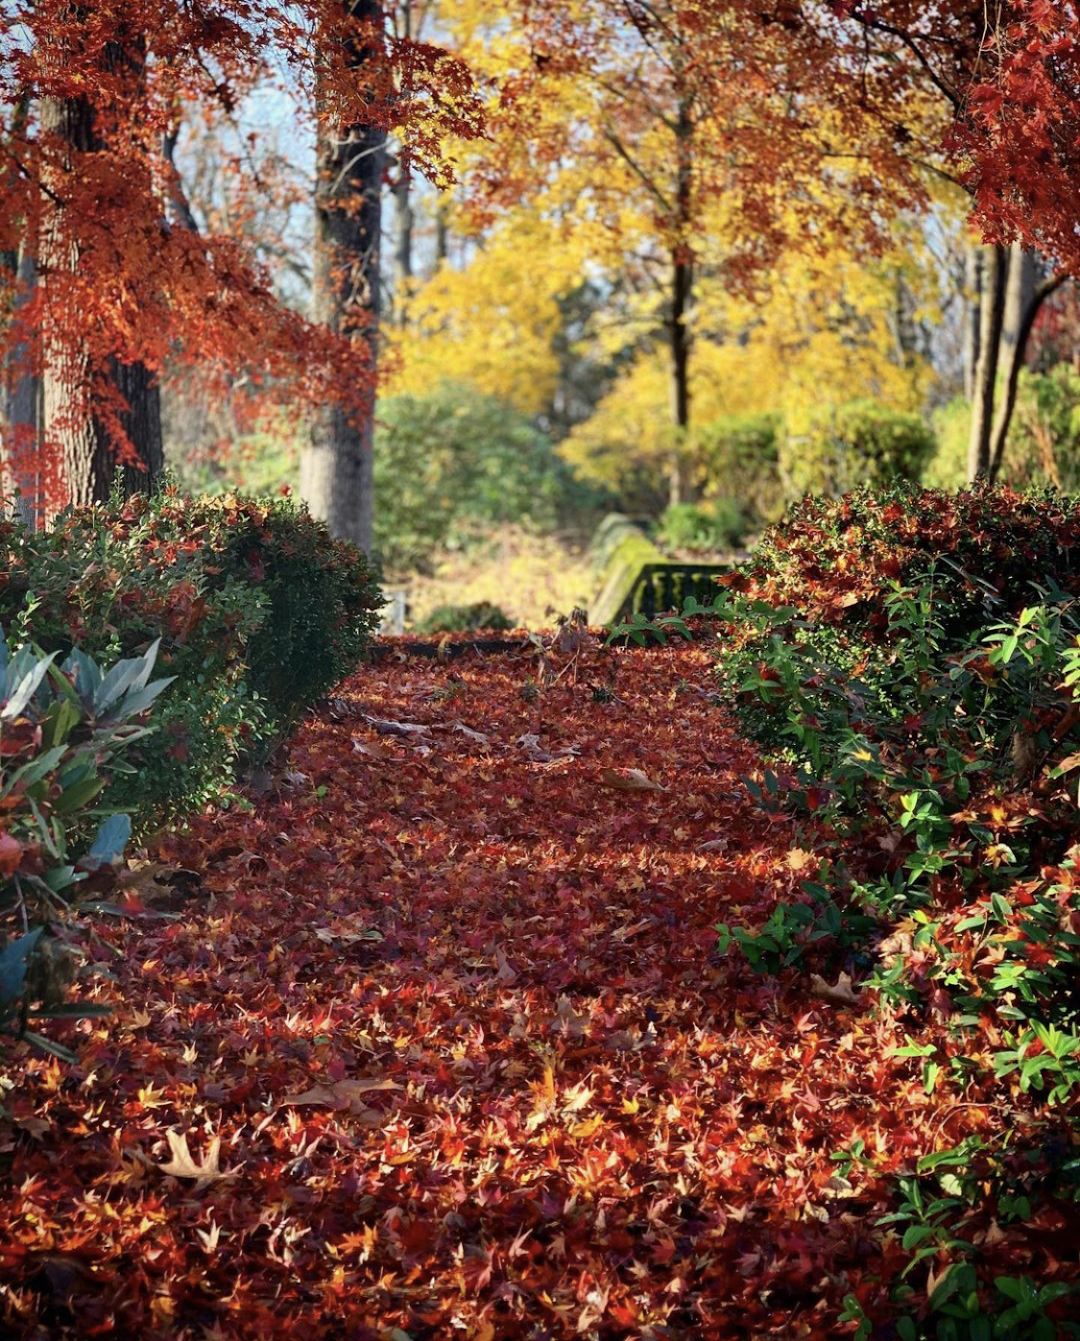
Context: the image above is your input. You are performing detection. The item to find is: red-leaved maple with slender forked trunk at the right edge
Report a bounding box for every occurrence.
[772,0,1080,479]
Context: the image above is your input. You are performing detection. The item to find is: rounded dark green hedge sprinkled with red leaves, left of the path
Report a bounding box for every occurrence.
[0,491,380,833]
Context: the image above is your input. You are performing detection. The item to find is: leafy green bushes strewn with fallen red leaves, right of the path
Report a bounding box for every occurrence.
[714,489,1080,1341]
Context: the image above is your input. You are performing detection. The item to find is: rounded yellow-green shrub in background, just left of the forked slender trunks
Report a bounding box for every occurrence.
[779,401,936,499]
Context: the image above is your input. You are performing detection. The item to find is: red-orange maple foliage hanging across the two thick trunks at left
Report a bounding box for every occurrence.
[0,0,479,504]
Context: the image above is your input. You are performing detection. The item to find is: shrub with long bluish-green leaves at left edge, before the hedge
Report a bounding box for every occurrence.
[0,636,169,1061]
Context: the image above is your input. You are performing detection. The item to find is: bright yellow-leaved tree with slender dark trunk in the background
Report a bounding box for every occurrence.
[392,0,955,506]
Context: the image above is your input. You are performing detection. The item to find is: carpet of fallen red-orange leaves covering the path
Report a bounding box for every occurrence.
[0,644,1008,1341]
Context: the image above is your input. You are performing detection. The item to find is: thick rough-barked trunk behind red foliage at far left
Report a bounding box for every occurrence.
[40,42,164,507]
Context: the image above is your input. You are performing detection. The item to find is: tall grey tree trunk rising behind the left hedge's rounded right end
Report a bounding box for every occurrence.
[301,0,386,554]
